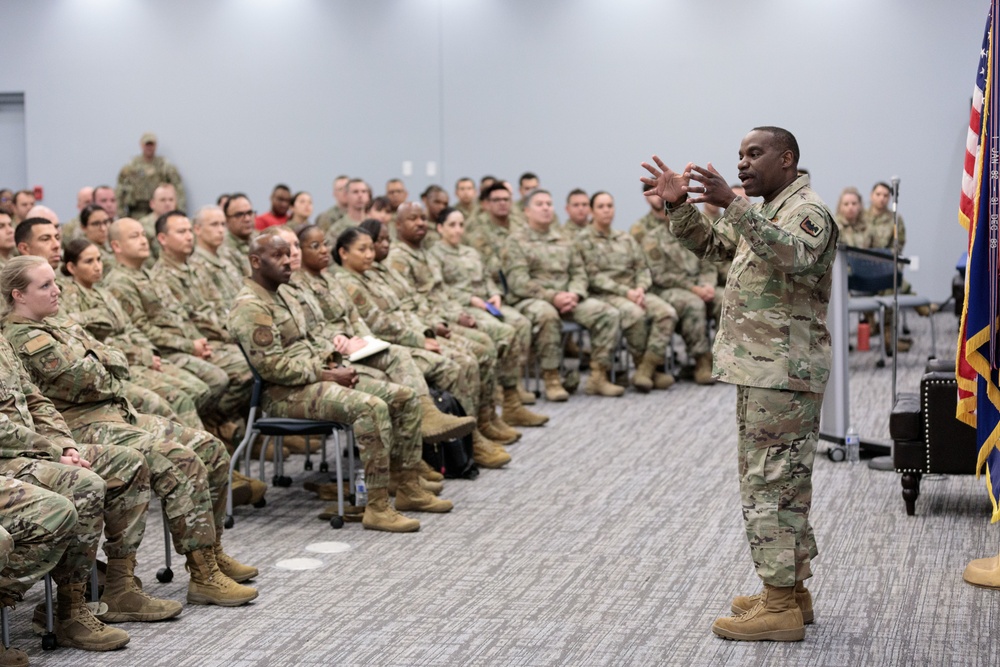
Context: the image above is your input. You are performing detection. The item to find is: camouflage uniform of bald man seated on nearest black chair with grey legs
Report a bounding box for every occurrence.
[229,279,422,489]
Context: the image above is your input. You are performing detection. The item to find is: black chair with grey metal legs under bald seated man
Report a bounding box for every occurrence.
[225,345,354,528]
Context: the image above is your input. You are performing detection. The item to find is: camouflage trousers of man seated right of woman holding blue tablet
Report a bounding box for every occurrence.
[514,299,619,371]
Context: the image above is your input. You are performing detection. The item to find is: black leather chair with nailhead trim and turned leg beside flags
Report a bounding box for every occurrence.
[889,360,979,516]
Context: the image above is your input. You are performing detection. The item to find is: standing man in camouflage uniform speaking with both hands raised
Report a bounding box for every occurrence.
[642,127,838,641]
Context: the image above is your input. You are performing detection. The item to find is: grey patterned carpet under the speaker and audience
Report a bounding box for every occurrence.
[11,313,1000,667]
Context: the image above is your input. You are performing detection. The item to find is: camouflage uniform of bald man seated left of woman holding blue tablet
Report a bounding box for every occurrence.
[385,243,500,406]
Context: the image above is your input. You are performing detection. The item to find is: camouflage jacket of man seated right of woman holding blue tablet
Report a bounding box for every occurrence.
[503,226,588,303]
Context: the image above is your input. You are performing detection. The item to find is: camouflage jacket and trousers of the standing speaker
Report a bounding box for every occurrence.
[670,176,838,587]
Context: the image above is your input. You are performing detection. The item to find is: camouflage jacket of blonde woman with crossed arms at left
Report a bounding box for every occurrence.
[3,313,136,427]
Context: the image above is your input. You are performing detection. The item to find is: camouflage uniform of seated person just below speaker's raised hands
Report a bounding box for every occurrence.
[642,216,722,357]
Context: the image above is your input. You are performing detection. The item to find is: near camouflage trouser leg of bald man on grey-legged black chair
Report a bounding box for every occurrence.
[262,379,394,489]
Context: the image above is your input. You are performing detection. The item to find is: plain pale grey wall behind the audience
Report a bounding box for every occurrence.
[0,0,989,298]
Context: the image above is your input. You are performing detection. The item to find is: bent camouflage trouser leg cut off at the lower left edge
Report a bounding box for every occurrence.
[0,478,77,602]
